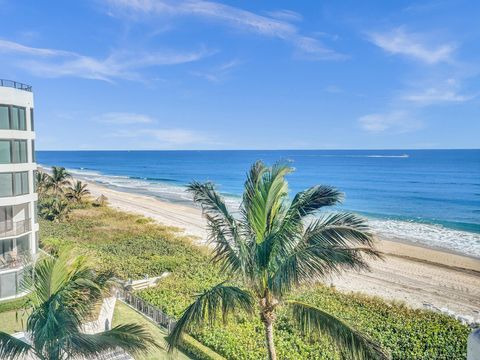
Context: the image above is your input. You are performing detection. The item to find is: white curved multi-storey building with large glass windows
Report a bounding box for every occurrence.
[0,79,38,300]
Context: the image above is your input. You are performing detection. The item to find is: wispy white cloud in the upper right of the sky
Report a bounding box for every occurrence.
[369,27,455,64]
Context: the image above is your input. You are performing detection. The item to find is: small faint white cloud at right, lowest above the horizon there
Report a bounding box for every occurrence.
[358,111,421,133]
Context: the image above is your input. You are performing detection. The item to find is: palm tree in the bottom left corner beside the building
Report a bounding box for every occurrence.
[0,252,158,360]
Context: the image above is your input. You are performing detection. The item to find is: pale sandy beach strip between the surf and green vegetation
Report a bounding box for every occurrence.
[83,179,480,320]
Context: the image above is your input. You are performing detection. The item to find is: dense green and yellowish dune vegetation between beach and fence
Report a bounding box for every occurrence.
[40,205,470,360]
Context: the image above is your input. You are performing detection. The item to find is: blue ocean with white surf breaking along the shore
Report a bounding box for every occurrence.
[37,150,480,258]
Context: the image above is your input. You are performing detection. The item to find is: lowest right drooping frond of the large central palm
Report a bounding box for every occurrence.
[288,301,390,360]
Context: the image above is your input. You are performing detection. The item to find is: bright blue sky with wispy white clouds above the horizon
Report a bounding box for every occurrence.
[0,0,480,150]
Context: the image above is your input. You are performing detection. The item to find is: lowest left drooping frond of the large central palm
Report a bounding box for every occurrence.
[168,283,254,351]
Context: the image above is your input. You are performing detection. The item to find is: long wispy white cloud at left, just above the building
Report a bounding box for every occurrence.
[0,40,212,82]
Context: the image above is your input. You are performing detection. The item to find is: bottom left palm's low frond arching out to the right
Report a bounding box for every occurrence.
[65,324,161,356]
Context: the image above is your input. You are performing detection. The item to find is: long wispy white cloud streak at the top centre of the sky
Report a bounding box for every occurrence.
[105,0,344,60]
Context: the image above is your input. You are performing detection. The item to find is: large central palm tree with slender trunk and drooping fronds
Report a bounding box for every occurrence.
[169,161,388,360]
